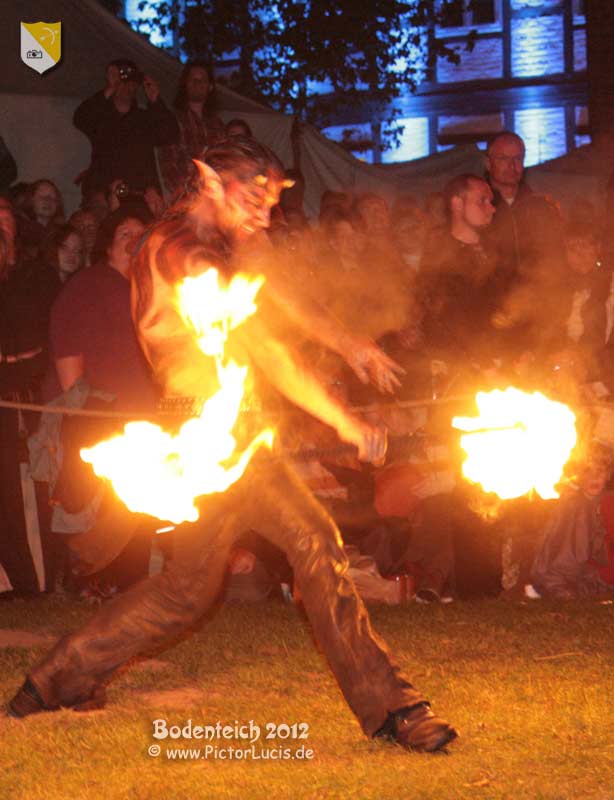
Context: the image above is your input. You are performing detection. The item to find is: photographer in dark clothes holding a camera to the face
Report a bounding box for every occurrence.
[73,59,179,196]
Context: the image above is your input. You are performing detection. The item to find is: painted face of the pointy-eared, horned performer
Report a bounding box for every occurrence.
[221,173,283,241]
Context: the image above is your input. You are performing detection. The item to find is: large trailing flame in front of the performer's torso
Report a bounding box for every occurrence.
[81,268,273,524]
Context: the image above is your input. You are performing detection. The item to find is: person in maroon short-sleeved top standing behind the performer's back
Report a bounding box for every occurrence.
[46,209,157,589]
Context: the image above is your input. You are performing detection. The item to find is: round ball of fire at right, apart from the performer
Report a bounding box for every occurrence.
[452,387,576,500]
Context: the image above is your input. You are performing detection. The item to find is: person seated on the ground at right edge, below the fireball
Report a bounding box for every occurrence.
[531,446,614,600]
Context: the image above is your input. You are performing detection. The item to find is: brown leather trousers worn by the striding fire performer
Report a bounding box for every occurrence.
[30,455,424,736]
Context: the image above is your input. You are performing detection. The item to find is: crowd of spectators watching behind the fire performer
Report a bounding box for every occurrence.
[0,59,614,603]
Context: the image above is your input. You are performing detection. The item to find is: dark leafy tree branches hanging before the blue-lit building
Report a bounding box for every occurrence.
[139,0,464,149]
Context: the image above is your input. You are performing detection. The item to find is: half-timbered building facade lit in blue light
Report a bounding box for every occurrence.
[126,0,589,165]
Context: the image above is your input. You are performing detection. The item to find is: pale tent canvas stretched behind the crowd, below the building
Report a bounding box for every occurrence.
[0,0,588,216]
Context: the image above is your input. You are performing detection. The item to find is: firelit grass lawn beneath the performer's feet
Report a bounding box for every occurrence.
[0,599,614,800]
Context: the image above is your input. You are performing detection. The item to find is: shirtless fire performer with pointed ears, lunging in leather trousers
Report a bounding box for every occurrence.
[9,139,456,752]
